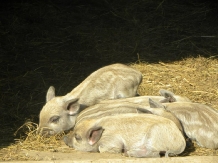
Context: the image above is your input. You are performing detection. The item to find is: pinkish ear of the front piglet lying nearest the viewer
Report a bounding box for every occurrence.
[87,127,104,145]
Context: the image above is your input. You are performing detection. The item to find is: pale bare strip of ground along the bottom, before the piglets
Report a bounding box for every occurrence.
[2,143,218,163]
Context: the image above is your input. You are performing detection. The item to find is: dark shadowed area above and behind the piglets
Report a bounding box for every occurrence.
[0,0,218,147]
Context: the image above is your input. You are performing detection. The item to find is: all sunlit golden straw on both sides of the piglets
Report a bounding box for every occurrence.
[0,57,218,160]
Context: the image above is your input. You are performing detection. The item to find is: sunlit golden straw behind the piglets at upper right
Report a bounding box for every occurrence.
[133,57,218,109]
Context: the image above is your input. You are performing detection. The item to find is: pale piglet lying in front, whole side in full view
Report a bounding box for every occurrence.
[64,113,186,157]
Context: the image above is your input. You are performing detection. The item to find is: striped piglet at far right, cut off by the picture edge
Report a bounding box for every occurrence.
[148,101,218,149]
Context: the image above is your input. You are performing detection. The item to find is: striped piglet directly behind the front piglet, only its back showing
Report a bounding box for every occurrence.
[75,101,183,132]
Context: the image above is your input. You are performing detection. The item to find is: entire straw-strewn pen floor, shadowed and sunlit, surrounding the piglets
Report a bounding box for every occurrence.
[0,0,218,163]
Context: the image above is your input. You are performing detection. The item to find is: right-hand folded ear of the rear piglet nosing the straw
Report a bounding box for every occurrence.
[65,98,80,115]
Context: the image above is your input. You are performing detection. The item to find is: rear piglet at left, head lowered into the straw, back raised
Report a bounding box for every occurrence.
[37,64,142,135]
